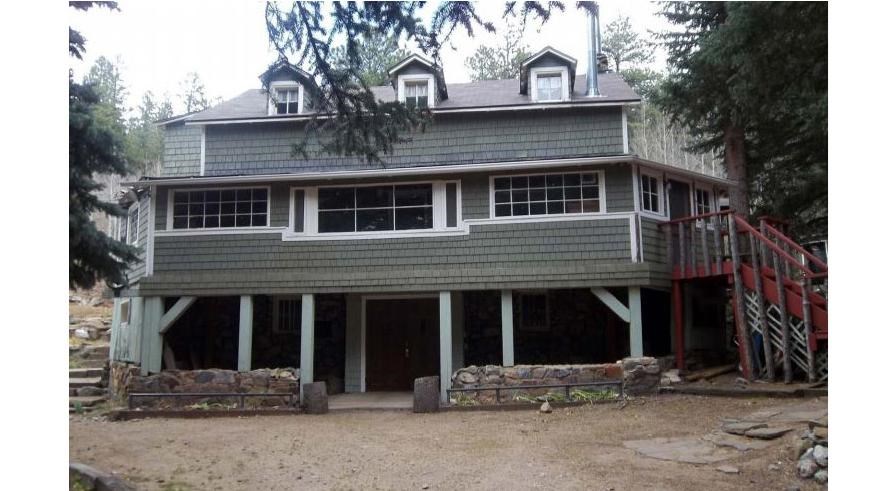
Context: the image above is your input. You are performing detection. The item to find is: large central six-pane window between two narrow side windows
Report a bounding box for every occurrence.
[318,183,434,233]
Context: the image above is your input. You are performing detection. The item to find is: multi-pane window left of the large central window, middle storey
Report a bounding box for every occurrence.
[173,188,269,229]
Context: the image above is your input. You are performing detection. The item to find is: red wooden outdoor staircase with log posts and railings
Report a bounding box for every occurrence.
[662,211,828,382]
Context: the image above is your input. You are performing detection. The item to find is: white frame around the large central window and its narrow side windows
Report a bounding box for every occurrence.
[282,180,469,241]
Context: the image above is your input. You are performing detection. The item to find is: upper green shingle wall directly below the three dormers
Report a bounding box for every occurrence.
[198,107,624,175]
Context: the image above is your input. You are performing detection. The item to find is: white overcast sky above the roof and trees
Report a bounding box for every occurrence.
[69,0,666,112]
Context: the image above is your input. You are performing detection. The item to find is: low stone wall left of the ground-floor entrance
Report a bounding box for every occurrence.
[111,363,300,409]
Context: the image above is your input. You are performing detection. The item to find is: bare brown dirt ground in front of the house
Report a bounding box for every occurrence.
[70,396,827,491]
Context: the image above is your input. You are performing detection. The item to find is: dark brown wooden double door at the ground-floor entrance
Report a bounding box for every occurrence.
[364,297,440,392]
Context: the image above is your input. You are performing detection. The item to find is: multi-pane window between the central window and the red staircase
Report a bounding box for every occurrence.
[494,172,602,217]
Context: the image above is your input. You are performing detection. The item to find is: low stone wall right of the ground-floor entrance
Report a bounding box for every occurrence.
[451,357,661,404]
